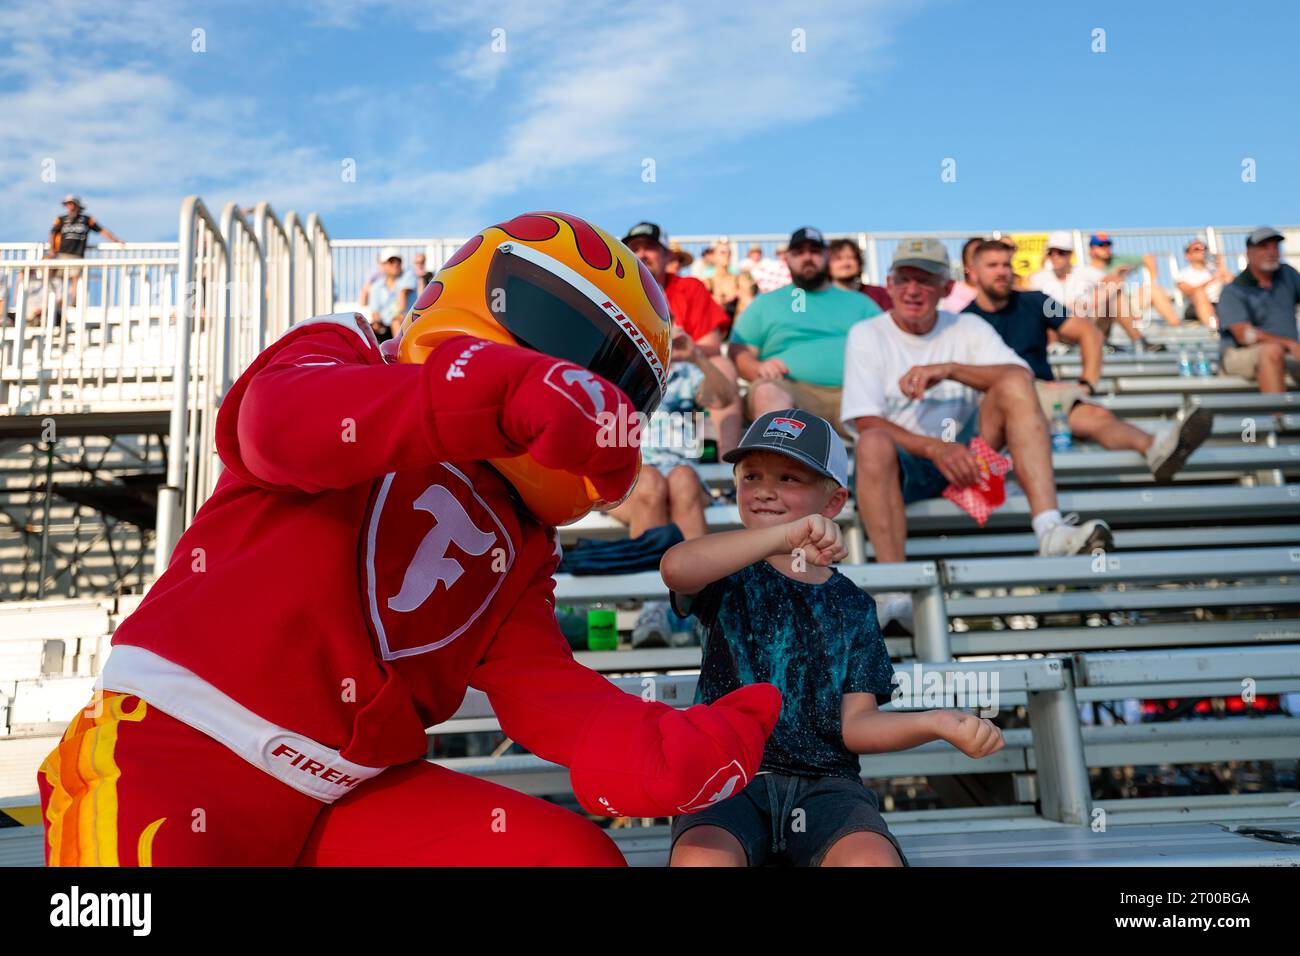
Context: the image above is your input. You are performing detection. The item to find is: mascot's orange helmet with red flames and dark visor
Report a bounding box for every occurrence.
[398,212,672,524]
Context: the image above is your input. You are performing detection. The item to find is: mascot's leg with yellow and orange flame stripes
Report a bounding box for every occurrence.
[36,691,325,866]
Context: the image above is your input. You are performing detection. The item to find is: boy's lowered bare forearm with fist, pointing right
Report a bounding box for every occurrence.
[840,693,1005,758]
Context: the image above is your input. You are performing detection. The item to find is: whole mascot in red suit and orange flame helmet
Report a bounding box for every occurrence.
[38,212,780,866]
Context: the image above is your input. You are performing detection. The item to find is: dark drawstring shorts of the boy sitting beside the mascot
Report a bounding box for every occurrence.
[672,773,907,866]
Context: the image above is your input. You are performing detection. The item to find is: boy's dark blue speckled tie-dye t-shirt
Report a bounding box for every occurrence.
[672,561,893,779]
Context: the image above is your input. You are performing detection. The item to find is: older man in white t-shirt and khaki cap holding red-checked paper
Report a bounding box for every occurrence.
[841,239,1112,630]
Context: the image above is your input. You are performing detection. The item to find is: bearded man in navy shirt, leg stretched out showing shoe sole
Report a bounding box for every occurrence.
[966,239,1214,481]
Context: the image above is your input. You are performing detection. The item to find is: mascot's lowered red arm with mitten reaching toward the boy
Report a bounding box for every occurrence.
[469,572,781,817]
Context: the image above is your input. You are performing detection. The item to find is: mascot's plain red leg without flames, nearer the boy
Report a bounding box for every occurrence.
[299,761,627,866]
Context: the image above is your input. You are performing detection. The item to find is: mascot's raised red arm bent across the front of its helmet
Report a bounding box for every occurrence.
[235,332,637,494]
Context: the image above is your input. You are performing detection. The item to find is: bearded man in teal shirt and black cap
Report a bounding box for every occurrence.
[729,226,880,440]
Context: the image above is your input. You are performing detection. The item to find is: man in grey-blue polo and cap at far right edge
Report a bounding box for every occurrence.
[1218,226,1300,392]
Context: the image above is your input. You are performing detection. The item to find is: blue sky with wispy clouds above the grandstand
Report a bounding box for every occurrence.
[0,0,1300,241]
